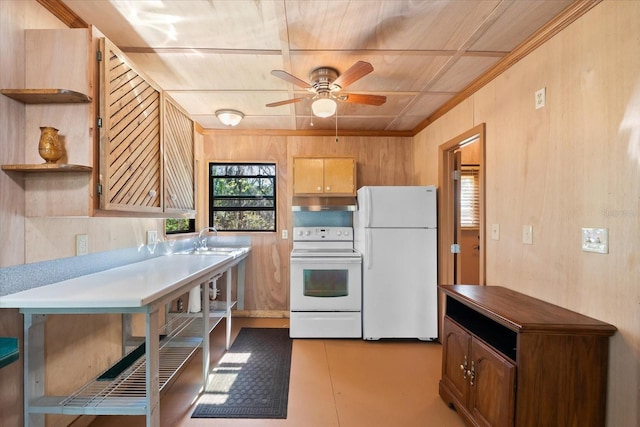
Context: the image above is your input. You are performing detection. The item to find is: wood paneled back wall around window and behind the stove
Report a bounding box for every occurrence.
[196,132,414,315]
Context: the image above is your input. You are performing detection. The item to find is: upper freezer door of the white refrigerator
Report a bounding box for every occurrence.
[353,186,437,228]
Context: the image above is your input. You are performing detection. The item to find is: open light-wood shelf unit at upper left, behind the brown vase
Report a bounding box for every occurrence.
[2,28,97,217]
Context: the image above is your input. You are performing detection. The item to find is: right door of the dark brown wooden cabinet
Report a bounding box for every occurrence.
[469,338,516,427]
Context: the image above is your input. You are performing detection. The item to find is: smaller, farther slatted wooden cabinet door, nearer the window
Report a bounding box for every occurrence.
[164,101,195,212]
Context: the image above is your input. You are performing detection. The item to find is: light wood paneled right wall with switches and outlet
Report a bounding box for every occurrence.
[414,1,640,427]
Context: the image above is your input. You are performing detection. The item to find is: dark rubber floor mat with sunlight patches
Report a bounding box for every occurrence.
[191,328,292,418]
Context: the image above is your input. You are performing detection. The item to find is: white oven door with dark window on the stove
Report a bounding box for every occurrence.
[290,257,362,311]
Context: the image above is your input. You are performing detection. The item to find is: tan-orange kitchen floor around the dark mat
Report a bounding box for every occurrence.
[85,318,464,427]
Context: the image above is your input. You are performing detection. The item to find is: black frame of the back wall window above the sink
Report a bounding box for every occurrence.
[207,161,278,233]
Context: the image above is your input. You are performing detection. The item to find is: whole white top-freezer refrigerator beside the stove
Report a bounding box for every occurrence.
[353,186,438,340]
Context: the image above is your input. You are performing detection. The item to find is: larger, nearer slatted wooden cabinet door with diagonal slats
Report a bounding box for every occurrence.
[100,40,162,212]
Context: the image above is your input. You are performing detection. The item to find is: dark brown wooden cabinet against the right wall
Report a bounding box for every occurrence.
[440,285,616,427]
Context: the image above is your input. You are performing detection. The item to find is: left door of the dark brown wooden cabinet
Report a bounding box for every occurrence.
[442,318,471,406]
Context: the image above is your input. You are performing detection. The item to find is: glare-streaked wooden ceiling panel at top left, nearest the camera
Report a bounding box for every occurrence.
[65,0,282,50]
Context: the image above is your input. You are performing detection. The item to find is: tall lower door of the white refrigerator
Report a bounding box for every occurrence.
[356,229,438,340]
